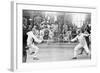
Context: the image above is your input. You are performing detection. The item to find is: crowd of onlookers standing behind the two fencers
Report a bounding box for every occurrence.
[23,17,91,42]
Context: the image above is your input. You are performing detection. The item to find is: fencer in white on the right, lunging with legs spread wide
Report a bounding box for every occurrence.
[71,29,90,59]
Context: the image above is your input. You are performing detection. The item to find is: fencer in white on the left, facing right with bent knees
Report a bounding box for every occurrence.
[27,29,42,58]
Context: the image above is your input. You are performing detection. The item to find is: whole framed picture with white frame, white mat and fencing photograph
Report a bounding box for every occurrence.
[11,2,97,71]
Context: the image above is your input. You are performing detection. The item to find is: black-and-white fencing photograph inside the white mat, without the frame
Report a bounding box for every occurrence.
[22,9,92,63]
